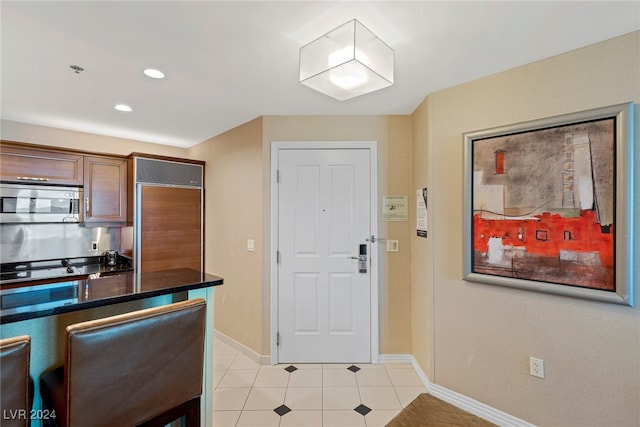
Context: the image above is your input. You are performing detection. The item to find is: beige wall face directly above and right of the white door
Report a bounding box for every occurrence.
[263,116,415,354]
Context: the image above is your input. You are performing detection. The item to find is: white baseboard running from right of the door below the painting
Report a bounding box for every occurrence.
[380,354,535,427]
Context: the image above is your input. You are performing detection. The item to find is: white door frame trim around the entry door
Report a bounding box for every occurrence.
[270,141,380,365]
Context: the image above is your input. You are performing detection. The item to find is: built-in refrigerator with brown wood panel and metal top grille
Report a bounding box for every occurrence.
[133,156,204,272]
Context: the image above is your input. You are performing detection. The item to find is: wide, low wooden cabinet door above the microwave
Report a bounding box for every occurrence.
[0,145,83,185]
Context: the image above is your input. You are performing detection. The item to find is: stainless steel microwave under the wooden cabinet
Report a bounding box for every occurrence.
[0,183,84,223]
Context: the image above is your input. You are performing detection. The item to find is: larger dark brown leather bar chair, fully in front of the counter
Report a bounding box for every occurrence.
[40,298,206,427]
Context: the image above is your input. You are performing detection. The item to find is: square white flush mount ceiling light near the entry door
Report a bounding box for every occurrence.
[300,19,393,101]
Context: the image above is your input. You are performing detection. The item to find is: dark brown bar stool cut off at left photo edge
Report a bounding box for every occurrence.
[0,335,33,427]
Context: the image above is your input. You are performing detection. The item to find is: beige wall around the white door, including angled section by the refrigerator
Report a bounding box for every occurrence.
[198,116,411,355]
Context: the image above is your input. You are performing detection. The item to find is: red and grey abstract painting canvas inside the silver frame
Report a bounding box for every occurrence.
[471,117,616,292]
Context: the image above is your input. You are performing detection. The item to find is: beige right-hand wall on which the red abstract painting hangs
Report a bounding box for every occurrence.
[412,32,640,426]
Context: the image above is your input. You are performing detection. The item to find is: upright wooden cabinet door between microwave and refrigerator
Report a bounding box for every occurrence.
[84,157,127,225]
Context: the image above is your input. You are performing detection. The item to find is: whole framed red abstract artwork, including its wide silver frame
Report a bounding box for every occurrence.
[463,103,634,306]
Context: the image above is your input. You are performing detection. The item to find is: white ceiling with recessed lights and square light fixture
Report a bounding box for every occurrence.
[0,0,640,147]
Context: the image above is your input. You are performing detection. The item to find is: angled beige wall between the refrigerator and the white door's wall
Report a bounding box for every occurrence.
[191,119,264,353]
